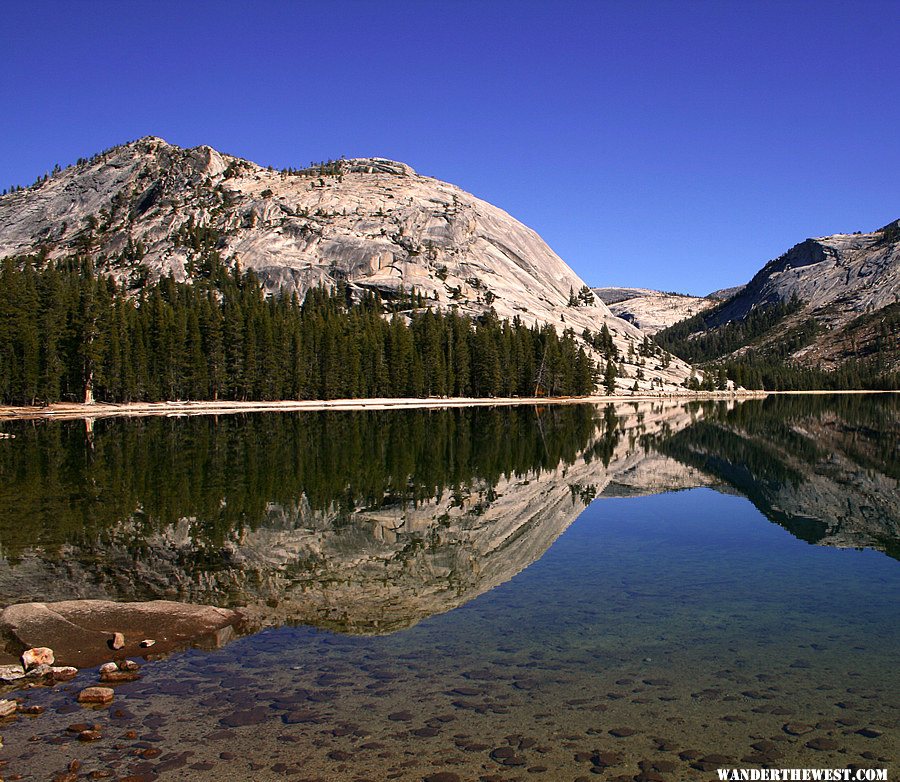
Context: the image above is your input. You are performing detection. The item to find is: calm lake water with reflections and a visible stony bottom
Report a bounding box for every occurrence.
[0,402,900,782]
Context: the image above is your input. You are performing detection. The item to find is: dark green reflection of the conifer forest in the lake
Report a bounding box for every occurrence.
[0,405,618,560]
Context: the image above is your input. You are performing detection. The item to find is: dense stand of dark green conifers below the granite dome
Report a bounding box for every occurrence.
[0,256,595,404]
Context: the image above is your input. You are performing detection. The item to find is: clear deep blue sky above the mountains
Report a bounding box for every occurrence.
[0,0,900,293]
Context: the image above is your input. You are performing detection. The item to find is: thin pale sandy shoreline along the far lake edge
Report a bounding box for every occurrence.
[0,390,900,421]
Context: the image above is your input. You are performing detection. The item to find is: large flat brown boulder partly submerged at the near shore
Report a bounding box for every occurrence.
[0,600,241,668]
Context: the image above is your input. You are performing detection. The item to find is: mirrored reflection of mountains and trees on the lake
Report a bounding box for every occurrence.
[0,395,900,634]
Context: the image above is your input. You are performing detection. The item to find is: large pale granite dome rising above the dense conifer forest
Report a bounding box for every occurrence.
[0,137,690,390]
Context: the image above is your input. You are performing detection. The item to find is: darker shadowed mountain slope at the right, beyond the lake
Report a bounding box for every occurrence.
[656,220,900,385]
